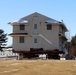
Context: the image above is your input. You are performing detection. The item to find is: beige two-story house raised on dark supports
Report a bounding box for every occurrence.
[9,12,67,59]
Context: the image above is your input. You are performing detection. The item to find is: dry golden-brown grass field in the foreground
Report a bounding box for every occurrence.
[0,60,76,75]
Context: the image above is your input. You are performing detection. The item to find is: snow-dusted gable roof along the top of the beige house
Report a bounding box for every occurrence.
[8,12,68,31]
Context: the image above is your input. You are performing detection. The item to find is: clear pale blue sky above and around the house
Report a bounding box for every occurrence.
[0,0,76,45]
